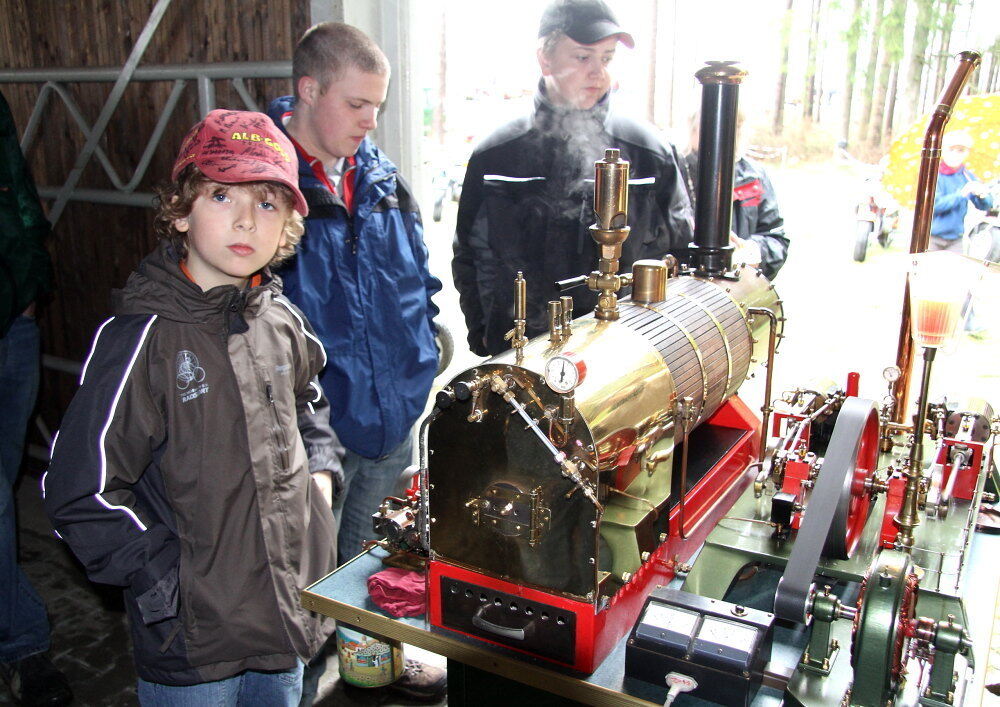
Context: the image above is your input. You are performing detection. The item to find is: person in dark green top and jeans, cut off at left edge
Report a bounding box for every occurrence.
[0,90,73,705]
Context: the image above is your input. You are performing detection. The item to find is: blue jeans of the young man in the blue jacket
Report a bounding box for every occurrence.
[333,435,413,564]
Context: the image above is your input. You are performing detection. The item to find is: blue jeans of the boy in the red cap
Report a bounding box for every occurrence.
[138,660,302,707]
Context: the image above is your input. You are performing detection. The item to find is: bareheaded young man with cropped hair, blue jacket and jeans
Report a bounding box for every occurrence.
[268,22,445,702]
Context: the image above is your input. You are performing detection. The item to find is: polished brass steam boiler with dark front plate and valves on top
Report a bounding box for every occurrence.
[427,151,783,601]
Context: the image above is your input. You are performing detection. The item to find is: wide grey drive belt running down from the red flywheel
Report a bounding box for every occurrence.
[774,397,875,623]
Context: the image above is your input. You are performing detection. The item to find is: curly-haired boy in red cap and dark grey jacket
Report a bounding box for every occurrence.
[42,110,343,705]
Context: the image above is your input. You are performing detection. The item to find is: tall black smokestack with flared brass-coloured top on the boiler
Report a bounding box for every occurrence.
[691,61,746,277]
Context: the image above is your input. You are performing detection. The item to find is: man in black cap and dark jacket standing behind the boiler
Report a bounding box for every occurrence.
[452,0,692,356]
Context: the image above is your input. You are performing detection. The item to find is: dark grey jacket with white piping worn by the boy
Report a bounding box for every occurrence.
[42,244,343,685]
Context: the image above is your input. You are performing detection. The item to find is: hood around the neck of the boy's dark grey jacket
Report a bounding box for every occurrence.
[111,241,281,334]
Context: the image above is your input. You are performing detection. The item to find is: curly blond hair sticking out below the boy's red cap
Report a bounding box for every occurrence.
[153,164,306,266]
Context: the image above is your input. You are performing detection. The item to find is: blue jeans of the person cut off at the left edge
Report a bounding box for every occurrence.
[0,316,49,663]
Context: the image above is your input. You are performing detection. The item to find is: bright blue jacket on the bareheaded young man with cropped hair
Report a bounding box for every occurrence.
[268,96,441,459]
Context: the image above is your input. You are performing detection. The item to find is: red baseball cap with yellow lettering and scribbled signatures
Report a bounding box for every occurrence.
[170,109,309,216]
